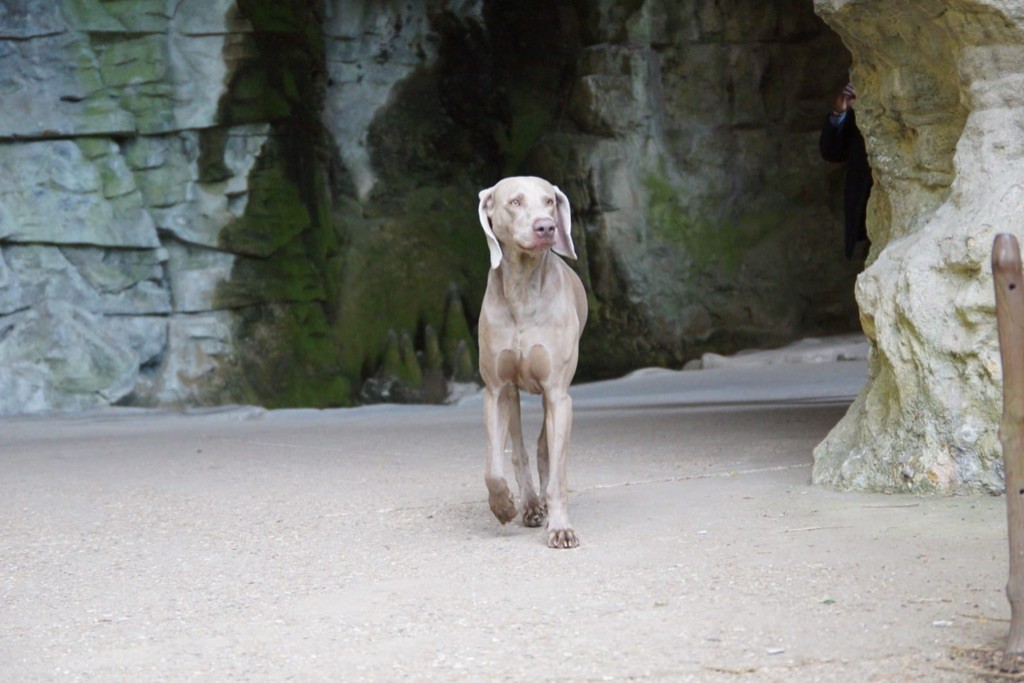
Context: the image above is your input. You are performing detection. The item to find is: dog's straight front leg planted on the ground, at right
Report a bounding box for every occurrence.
[544,392,580,548]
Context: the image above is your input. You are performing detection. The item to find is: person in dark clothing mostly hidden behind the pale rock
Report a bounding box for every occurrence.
[819,83,873,259]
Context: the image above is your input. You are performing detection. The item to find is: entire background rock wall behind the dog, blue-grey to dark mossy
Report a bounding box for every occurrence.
[0,0,864,414]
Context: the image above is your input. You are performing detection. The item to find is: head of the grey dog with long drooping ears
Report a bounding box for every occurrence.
[479,176,577,268]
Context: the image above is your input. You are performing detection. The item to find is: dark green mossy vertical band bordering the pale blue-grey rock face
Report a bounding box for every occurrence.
[214,0,346,408]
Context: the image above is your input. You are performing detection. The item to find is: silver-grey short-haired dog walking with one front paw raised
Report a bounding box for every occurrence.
[479,176,587,548]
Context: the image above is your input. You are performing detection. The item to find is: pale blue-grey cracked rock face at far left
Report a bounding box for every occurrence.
[0,1,245,413]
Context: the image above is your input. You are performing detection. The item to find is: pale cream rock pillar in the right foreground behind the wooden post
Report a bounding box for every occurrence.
[814,0,1024,492]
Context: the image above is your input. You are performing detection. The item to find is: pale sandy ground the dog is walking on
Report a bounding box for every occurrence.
[0,344,1009,682]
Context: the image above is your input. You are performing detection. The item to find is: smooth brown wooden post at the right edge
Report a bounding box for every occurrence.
[992,233,1024,663]
